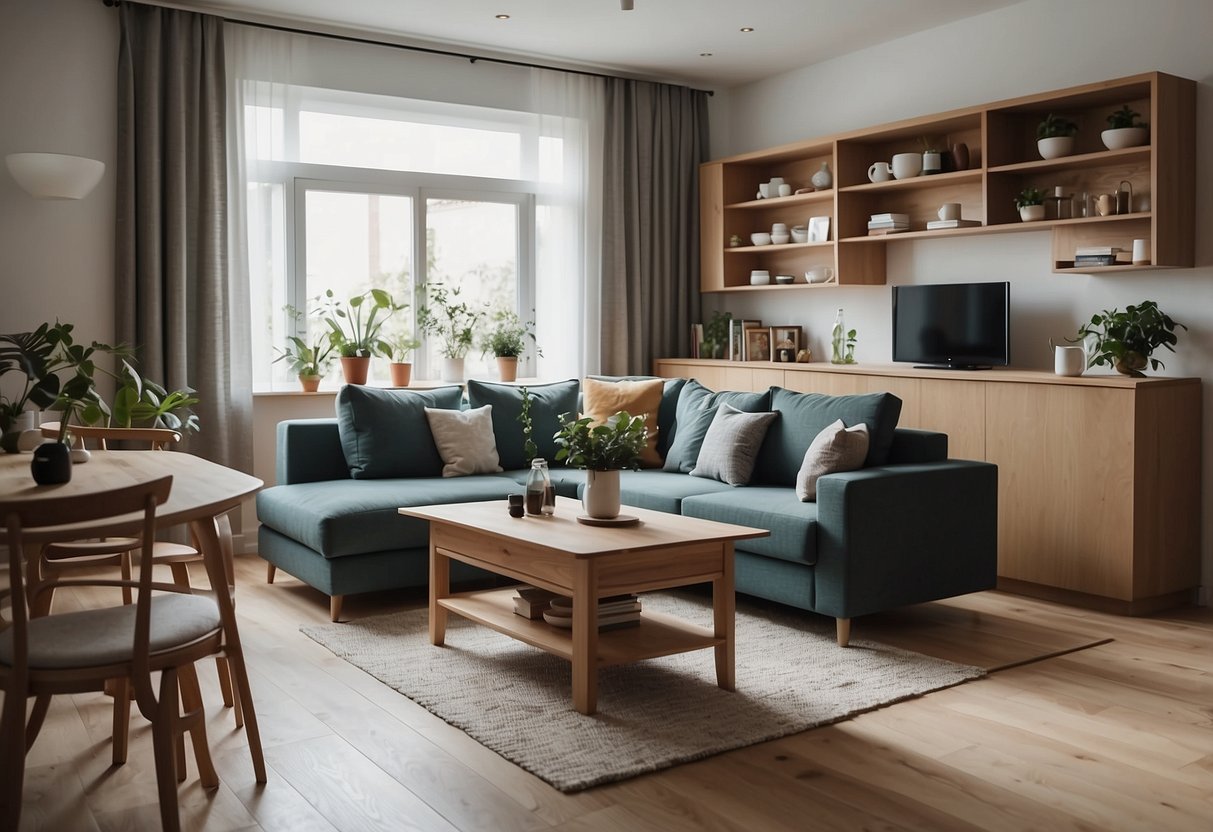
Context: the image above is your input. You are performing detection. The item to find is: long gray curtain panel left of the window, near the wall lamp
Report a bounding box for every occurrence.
[115,2,252,471]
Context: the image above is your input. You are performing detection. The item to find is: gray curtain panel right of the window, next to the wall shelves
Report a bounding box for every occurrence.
[602,79,707,375]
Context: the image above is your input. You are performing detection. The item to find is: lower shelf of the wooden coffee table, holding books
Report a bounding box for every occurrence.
[438,589,724,667]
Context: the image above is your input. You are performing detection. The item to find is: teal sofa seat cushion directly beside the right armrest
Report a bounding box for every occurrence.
[682,485,818,565]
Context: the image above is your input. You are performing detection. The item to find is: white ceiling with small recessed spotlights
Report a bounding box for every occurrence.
[186,0,1019,87]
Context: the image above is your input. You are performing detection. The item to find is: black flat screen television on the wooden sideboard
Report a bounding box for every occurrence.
[893,283,1010,370]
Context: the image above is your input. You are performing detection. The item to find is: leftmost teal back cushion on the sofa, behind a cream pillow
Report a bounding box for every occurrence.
[337,384,463,479]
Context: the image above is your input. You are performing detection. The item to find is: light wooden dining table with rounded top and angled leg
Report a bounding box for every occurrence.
[0,450,266,782]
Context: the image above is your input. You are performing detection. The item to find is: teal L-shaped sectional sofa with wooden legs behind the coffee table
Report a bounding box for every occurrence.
[257,378,998,645]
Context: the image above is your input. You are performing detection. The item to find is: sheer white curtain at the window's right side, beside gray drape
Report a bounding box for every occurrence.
[531,69,607,378]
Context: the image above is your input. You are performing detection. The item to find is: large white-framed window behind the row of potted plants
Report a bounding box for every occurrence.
[244,82,548,389]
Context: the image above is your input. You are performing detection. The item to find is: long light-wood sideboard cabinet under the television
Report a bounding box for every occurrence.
[655,359,1201,615]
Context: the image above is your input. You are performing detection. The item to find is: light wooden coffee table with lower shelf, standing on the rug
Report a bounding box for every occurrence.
[399,497,770,713]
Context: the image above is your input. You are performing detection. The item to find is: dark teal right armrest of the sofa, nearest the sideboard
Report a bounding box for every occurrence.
[814,460,998,619]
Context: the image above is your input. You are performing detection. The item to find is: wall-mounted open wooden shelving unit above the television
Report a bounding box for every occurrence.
[700,73,1196,292]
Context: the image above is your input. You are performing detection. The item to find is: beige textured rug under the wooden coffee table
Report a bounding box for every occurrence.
[302,593,985,792]
